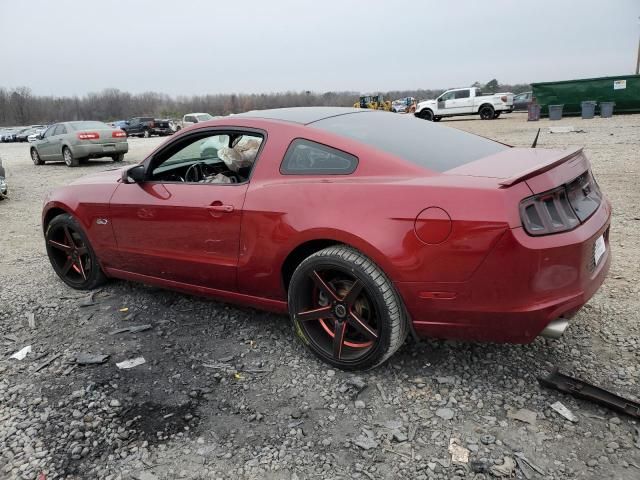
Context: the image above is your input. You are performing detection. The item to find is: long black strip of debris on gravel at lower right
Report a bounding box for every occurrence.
[538,367,640,418]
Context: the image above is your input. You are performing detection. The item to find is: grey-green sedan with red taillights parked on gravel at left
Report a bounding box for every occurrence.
[30,121,129,167]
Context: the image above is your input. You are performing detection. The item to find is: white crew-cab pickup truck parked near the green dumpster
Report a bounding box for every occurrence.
[415,87,513,122]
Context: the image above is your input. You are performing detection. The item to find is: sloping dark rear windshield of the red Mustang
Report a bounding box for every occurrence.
[310,111,509,172]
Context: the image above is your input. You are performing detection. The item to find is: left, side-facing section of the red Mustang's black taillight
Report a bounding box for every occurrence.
[520,186,580,235]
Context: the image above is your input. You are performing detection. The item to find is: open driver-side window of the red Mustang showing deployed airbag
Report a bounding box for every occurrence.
[151,132,263,184]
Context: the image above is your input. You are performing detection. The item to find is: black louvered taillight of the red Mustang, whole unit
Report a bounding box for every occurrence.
[520,171,602,235]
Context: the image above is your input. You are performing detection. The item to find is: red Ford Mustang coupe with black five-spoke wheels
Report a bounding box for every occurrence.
[42,107,611,369]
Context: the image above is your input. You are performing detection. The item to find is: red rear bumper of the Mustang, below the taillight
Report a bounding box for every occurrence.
[396,200,611,343]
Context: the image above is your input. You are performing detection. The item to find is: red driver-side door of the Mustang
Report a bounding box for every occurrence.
[110,130,262,291]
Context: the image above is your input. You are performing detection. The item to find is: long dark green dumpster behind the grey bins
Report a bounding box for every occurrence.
[531,75,640,116]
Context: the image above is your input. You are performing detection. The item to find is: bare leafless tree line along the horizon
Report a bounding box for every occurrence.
[0,79,530,126]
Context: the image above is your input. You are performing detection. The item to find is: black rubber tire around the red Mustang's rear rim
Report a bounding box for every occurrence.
[288,246,408,370]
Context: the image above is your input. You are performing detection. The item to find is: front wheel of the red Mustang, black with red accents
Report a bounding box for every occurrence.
[44,213,107,290]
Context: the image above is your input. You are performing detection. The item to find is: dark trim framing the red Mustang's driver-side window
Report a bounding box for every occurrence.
[142,126,268,187]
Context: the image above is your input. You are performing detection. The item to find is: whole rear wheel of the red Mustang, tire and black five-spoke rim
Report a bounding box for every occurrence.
[288,245,409,370]
